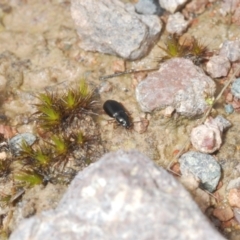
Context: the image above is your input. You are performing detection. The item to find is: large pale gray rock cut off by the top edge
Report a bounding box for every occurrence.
[71,0,162,60]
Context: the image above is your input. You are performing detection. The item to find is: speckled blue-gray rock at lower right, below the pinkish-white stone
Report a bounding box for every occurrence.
[179,151,221,192]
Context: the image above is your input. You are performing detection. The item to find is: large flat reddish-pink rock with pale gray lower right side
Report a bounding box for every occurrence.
[136,58,216,117]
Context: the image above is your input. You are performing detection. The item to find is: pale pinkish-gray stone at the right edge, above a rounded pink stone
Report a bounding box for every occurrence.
[219,40,240,62]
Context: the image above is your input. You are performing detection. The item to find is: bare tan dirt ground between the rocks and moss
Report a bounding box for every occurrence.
[0,0,240,239]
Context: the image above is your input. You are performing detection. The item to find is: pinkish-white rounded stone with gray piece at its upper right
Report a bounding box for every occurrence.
[191,116,231,153]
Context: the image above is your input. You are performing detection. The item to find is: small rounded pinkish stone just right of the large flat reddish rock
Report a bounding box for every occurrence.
[206,56,231,78]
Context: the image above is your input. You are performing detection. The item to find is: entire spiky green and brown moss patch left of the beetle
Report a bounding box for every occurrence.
[0,79,98,187]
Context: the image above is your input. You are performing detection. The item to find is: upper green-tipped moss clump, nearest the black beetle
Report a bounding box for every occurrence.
[35,79,96,132]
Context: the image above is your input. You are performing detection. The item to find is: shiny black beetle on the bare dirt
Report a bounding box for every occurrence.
[103,100,132,128]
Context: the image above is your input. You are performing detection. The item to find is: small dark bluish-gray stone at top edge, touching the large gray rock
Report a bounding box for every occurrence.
[135,0,164,16]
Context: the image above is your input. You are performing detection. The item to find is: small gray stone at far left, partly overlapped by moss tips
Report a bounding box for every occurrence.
[9,133,37,156]
